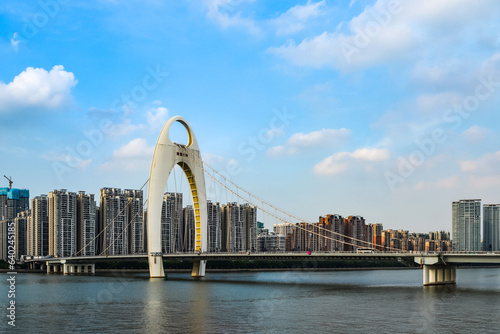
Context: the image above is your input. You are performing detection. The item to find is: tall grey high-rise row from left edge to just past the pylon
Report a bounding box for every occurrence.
[0,188,258,259]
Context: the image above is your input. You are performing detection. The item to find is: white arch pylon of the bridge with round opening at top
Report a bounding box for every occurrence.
[147,116,207,277]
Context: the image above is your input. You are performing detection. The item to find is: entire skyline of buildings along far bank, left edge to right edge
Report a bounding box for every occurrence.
[0,188,500,259]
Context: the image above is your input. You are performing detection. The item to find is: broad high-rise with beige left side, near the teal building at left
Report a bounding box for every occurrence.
[49,189,77,257]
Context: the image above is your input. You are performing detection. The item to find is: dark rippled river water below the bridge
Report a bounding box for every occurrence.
[0,268,500,333]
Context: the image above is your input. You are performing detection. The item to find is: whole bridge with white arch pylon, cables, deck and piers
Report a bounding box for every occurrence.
[26,116,500,285]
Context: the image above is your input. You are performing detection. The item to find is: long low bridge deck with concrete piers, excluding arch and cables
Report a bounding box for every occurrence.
[26,252,500,286]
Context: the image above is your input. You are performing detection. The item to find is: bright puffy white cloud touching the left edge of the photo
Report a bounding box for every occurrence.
[0,65,78,112]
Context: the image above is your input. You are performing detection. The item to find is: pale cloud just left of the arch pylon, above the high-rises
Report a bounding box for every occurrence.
[99,138,154,172]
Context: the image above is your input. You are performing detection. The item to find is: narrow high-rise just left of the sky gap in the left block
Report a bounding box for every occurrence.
[76,191,97,256]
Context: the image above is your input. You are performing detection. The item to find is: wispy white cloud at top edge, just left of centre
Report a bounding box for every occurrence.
[206,0,260,34]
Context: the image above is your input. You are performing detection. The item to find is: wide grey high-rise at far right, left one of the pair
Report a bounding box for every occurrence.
[452,199,481,252]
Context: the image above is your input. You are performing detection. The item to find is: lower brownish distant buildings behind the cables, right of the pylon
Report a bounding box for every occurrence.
[273,214,452,252]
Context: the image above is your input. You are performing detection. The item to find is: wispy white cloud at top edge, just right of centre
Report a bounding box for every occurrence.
[271,0,325,35]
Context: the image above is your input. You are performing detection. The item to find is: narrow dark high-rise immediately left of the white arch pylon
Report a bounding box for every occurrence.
[124,189,146,254]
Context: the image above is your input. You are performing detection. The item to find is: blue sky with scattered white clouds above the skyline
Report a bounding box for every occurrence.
[0,0,500,232]
